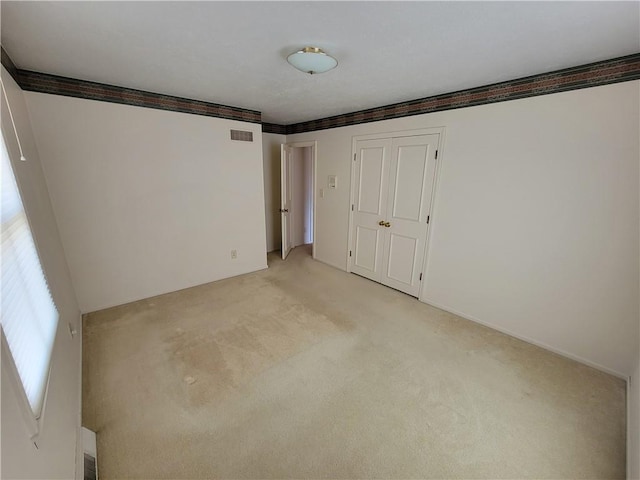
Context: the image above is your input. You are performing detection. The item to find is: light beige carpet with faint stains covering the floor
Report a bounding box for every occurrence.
[83,247,625,480]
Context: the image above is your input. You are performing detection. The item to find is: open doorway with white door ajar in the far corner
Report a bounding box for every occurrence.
[280,142,316,259]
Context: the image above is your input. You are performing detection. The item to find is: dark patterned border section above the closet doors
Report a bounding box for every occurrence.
[280,53,640,135]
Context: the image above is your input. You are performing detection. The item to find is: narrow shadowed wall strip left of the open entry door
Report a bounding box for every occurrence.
[262,133,287,252]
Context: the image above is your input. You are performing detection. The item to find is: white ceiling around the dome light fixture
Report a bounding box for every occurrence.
[0,0,640,124]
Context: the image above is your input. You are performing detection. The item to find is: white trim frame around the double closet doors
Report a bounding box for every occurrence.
[348,127,446,302]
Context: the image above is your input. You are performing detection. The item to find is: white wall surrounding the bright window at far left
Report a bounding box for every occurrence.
[1,68,83,478]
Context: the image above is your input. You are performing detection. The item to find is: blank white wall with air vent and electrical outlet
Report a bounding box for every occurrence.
[25,92,267,312]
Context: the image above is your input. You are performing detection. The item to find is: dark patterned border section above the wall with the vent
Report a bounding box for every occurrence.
[2,48,262,123]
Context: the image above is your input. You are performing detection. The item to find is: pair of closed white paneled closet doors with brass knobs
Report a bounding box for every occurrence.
[350,134,439,297]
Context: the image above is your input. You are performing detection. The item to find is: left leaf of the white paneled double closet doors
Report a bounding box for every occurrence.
[350,139,391,282]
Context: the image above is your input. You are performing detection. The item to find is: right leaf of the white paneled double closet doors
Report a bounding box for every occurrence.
[379,134,439,297]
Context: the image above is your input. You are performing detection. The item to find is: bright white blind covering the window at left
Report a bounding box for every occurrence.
[0,135,58,418]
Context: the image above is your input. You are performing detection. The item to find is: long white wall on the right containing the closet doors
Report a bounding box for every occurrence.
[287,82,640,376]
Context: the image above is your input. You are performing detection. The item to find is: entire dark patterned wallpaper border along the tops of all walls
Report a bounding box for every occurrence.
[1,48,640,135]
